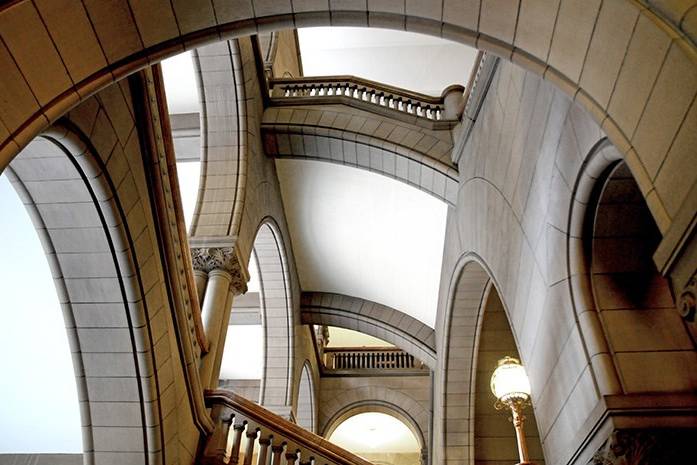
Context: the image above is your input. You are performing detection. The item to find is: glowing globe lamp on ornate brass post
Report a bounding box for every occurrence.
[491,357,533,465]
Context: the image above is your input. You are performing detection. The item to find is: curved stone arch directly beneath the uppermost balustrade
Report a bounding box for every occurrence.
[262,105,457,205]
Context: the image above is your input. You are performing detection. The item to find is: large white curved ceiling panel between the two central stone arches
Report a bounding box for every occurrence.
[276,159,447,327]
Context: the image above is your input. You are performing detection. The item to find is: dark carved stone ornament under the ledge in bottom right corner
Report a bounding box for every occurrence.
[588,429,697,465]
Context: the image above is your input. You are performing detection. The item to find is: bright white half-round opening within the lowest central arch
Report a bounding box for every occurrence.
[329,412,420,455]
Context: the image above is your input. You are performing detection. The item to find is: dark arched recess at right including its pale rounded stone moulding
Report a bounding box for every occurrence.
[568,139,697,394]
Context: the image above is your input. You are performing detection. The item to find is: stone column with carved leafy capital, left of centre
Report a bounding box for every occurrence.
[191,247,248,389]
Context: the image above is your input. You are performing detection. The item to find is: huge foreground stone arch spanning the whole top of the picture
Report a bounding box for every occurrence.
[0,0,697,241]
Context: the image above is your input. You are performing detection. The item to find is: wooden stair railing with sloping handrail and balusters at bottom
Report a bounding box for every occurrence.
[197,390,372,465]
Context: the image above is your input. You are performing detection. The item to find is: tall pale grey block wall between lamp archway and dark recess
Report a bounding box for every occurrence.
[436,56,695,463]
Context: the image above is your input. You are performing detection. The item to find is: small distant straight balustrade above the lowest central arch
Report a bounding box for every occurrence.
[324,347,423,370]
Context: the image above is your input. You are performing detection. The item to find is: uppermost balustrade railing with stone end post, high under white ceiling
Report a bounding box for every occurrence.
[269,76,464,121]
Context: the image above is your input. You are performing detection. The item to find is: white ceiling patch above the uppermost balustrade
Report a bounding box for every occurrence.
[298,27,477,96]
